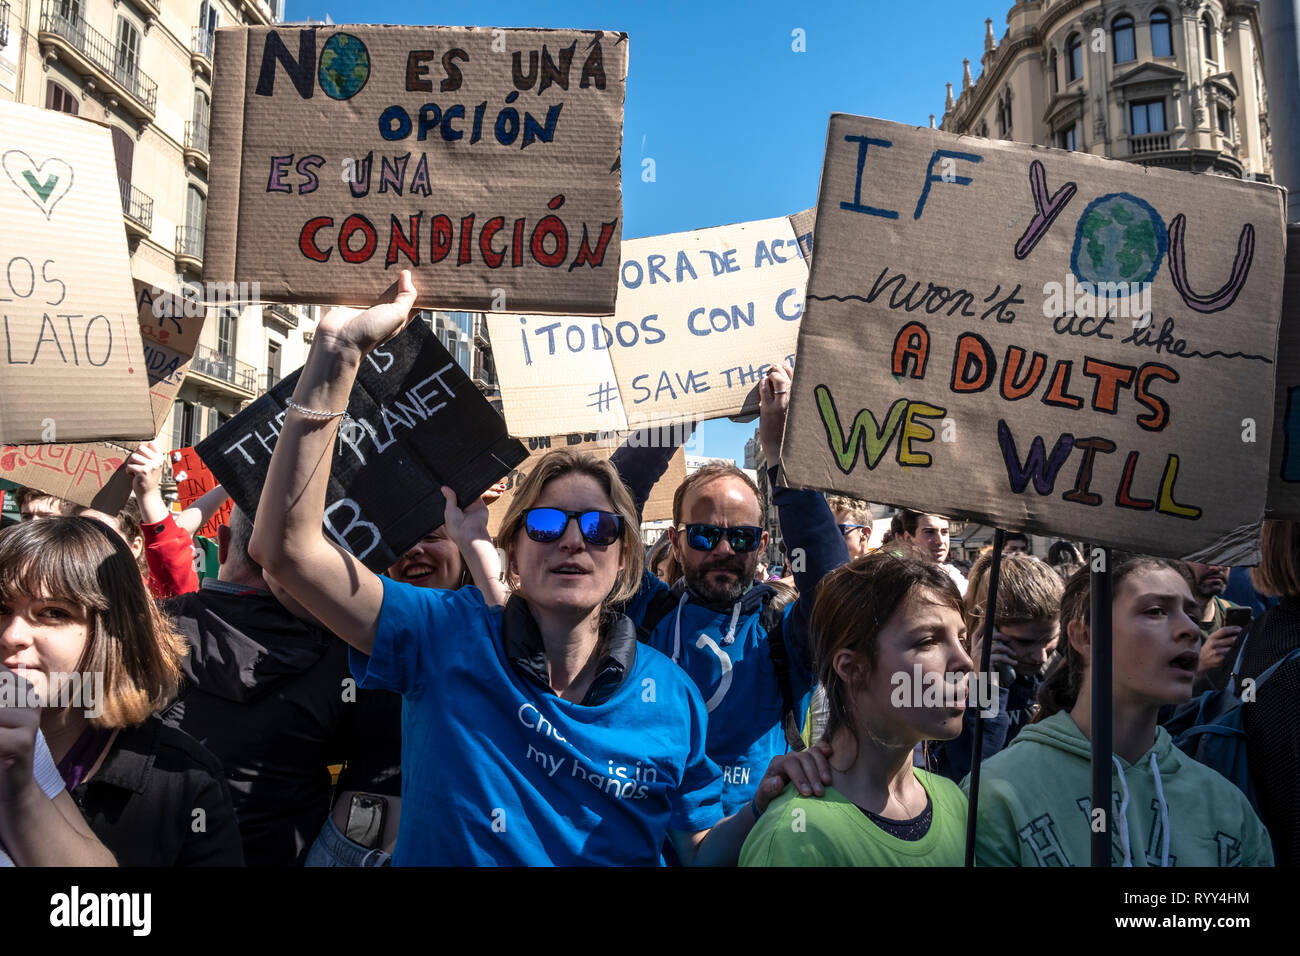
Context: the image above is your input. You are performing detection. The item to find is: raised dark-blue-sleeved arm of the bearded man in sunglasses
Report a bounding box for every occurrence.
[758,365,849,670]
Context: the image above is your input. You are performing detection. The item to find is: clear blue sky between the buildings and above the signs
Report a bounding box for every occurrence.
[297,0,1011,459]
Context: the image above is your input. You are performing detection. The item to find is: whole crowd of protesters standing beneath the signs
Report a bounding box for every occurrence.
[0,274,1300,866]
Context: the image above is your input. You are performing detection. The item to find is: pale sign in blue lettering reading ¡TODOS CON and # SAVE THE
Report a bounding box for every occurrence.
[488,213,807,436]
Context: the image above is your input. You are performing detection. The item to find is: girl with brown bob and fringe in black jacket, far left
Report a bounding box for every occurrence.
[0,518,243,866]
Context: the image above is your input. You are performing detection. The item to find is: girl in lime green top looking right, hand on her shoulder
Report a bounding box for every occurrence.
[740,551,972,866]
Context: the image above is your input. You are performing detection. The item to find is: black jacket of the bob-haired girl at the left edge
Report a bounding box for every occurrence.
[72,715,243,866]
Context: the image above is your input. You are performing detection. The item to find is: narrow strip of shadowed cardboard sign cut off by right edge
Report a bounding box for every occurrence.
[1265,222,1300,522]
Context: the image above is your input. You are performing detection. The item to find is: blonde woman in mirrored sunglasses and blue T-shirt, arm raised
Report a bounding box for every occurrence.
[252,271,807,865]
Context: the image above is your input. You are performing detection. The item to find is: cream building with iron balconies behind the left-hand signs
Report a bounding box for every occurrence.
[0,0,499,476]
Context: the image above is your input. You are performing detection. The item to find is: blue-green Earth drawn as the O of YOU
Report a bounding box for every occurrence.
[1070,193,1169,295]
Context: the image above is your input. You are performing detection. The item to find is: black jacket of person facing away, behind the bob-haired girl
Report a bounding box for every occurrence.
[163,581,400,866]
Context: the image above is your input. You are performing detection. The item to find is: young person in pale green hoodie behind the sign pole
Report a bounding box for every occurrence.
[963,555,1273,866]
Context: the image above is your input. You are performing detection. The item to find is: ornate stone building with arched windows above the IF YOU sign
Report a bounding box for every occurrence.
[931,0,1273,182]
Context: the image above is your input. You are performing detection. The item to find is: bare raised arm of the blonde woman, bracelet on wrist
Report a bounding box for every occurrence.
[248,269,416,654]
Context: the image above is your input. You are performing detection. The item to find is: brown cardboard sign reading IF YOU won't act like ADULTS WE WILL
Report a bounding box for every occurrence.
[783,114,1283,564]
